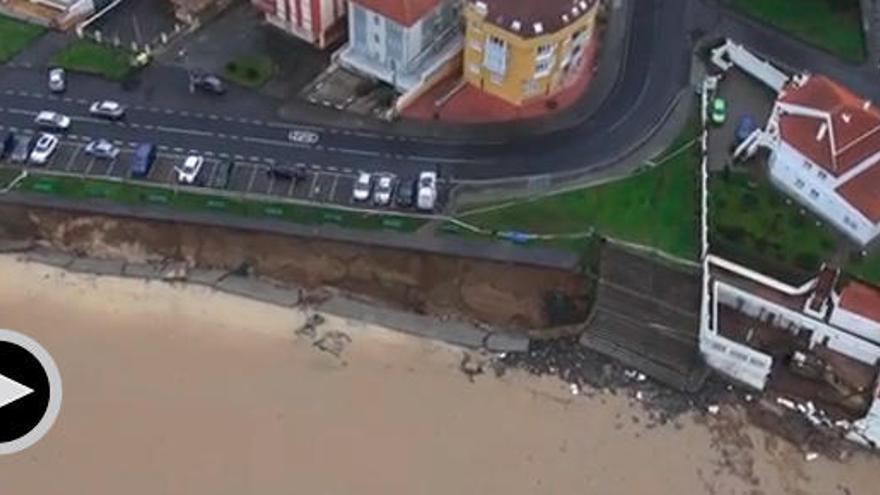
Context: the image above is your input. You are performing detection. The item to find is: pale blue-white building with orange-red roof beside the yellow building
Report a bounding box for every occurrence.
[338,0,464,98]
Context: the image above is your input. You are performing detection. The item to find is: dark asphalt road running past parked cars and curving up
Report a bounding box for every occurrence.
[0,0,690,180]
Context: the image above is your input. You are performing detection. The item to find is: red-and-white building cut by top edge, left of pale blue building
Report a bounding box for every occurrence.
[252,0,347,48]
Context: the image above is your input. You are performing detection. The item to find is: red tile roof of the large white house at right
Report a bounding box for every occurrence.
[779,76,880,176]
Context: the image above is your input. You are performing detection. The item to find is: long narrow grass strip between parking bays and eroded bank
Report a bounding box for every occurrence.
[12,169,425,232]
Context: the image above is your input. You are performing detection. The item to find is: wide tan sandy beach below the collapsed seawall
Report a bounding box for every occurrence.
[0,256,880,495]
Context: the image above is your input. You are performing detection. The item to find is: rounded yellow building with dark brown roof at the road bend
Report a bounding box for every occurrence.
[463,0,599,105]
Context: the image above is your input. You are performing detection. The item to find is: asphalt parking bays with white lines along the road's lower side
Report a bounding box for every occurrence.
[0,126,446,211]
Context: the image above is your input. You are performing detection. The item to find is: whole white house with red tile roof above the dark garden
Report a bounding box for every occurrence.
[760,75,880,246]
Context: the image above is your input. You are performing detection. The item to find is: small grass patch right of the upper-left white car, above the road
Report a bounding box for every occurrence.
[51,40,132,81]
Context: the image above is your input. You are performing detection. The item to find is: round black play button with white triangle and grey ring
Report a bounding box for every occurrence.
[0,329,61,454]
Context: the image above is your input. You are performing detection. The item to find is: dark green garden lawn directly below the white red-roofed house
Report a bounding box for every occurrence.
[709,172,837,281]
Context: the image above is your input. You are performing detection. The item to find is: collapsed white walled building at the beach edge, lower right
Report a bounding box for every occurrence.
[700,256,880,448]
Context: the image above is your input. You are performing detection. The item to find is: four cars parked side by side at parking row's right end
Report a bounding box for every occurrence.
[352,171,437,211]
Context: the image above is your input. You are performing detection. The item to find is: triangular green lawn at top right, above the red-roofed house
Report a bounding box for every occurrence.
[726,0,865,62]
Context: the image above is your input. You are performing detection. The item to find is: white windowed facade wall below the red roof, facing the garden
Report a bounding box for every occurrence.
[769,141,880,245]
